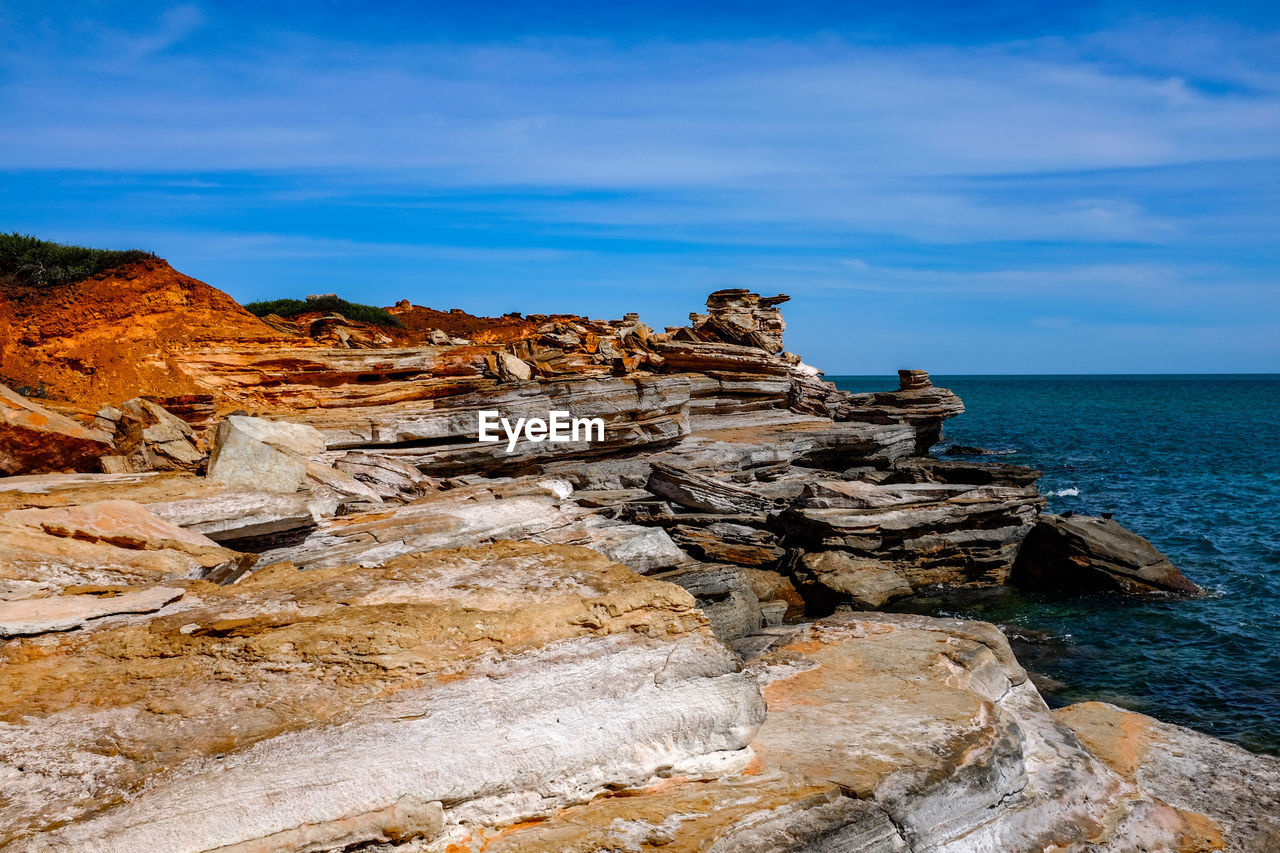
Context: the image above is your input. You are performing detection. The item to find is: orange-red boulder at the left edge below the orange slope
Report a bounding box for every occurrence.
[0,386,113,475]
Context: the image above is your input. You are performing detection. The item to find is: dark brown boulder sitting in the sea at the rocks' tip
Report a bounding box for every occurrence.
[1012,515,1204,596]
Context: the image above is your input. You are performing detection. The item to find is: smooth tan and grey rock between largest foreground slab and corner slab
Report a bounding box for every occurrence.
[753,613,1211,853]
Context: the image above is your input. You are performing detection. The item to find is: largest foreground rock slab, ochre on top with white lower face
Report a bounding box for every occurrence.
[0,544,764,853]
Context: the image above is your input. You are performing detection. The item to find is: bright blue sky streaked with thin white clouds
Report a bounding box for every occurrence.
[0,0,1280,374]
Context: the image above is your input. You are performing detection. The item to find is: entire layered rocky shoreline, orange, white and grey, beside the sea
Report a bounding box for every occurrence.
[0,261,1280,853]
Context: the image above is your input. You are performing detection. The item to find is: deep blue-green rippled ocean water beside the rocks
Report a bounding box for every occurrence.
[828,375,1280,754]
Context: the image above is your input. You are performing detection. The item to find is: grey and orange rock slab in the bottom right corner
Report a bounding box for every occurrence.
[1053,702,1280,853]
